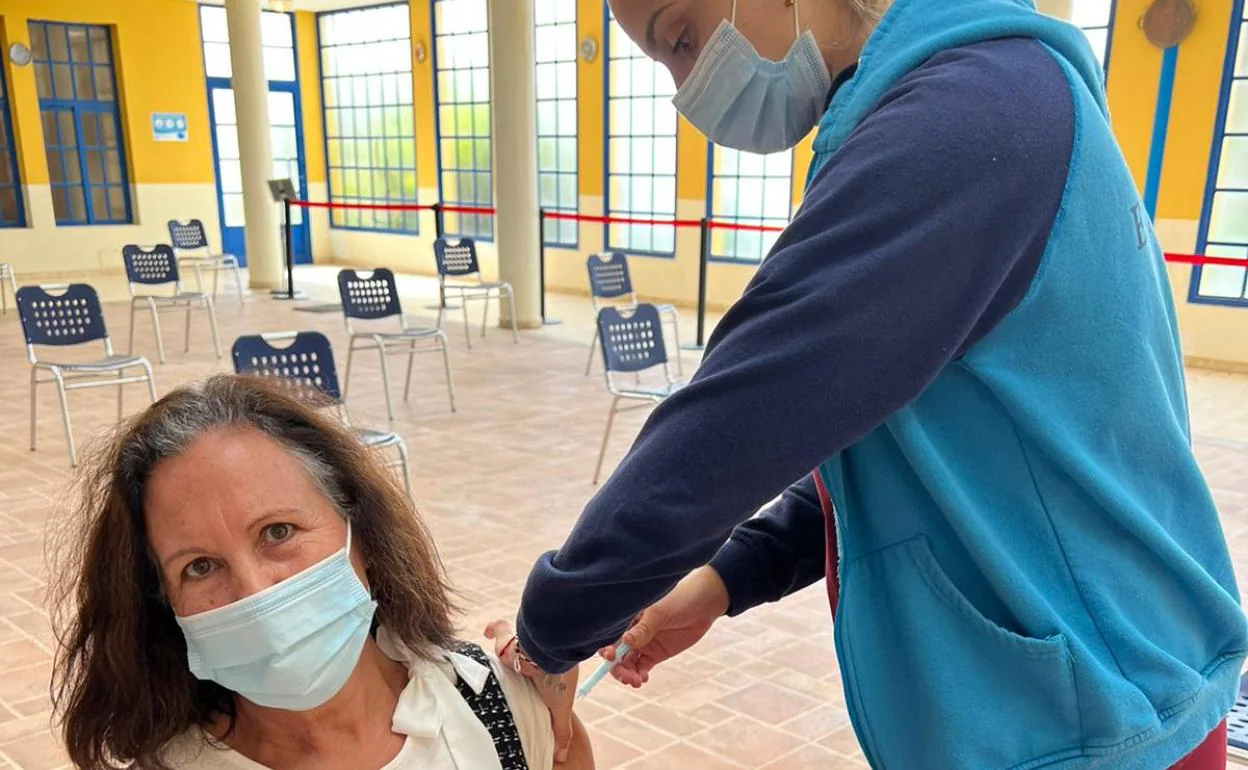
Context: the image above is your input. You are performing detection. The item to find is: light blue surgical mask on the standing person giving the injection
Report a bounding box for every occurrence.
[671,0,832,152]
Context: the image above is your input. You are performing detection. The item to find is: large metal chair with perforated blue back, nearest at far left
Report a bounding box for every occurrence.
[17,283,156,465]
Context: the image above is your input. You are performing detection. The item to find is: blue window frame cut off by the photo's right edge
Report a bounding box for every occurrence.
[1187,0,1248,307]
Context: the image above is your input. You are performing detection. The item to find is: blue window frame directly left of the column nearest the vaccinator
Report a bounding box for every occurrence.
[429,0,495,243]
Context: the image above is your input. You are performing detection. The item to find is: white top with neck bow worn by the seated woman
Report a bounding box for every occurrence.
[165,628,554,770]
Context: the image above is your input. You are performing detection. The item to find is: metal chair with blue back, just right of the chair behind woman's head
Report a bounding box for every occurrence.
[338,267,456,422]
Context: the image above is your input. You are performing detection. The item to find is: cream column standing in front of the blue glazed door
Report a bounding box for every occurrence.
[226,0,285,288]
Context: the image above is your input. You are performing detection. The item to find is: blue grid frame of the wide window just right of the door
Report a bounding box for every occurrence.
[319,0,421,236]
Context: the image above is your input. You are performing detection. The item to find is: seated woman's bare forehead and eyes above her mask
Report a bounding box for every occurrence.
[144,427,367,616]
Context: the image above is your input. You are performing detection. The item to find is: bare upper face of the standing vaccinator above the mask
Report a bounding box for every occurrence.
[610,0,794,86]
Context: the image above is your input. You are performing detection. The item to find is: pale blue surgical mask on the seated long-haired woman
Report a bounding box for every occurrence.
[177,522,377,711]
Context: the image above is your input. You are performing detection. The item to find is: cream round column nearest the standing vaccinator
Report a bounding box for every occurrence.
[489,0,542,328]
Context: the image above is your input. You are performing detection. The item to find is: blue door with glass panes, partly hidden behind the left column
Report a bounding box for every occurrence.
[208,77,312,265]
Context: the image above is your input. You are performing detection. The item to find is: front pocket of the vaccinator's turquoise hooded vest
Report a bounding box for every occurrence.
[837,535,1082,770]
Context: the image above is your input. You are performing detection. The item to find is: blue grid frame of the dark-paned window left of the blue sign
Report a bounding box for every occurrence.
[27,19,135,227]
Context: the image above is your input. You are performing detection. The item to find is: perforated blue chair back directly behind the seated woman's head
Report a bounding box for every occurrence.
[231,332,342,402]
